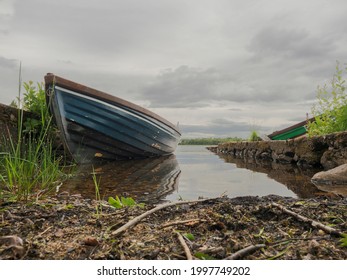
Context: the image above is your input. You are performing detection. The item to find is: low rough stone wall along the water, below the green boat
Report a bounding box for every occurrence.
[210,132,347,170]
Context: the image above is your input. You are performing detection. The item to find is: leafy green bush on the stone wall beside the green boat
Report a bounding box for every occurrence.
[307,62,347,136]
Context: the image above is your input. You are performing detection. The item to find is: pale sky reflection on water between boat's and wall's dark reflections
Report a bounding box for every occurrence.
[167,146,296,200]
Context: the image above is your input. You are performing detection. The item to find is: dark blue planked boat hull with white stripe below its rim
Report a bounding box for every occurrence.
[46,73,180,162]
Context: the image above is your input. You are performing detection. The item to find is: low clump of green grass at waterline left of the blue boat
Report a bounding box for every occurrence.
[0,135,64,201]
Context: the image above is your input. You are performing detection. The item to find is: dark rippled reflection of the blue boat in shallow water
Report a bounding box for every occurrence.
[61,155,181,203]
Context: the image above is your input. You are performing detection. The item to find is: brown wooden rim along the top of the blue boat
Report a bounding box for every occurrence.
[45,73,181,134]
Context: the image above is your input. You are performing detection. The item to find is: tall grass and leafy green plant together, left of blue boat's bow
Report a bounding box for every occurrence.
[0,79,65,200]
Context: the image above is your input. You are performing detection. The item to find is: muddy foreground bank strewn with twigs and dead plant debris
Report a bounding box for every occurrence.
[0,195,347,260]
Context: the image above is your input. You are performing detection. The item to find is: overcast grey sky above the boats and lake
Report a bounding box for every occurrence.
[0,0,347,138]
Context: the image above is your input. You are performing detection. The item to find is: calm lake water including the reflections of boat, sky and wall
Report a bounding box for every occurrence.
[60,146,321,202]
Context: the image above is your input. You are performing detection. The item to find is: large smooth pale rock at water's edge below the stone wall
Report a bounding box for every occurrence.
[311,164,347,185]
